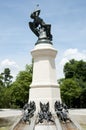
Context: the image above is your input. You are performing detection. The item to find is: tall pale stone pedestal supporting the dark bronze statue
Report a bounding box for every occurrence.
[29,40,61,112]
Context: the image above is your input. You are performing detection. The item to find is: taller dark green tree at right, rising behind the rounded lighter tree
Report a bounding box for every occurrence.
[64,59,86,81]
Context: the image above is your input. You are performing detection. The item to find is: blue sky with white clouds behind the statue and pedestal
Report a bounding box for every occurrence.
[0,0,86,79]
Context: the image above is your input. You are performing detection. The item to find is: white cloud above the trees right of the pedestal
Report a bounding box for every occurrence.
[57,48,86,79]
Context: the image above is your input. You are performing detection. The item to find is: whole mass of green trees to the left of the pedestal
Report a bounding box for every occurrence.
[0,65,32,108]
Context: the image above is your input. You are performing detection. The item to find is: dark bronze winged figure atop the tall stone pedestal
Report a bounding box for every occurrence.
[29,9,52,41]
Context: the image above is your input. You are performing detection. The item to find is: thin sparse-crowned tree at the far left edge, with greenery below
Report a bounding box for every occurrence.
[0,68,13,108]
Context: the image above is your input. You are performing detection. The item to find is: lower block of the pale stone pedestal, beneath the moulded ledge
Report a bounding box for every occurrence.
[29,87,61,112]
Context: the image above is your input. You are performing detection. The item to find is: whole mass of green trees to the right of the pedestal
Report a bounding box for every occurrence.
[59,59,86,107]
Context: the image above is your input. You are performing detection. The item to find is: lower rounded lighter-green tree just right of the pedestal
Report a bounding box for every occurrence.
[60,79,82,107]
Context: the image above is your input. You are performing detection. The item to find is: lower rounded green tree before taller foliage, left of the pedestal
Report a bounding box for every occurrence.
[10,82,29,108]
